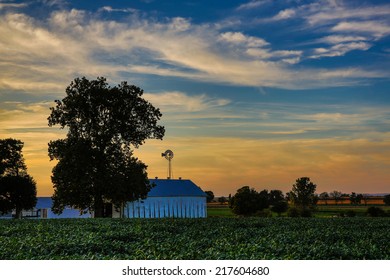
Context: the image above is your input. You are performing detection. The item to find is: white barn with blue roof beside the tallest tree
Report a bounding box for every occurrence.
[124,178,207,218]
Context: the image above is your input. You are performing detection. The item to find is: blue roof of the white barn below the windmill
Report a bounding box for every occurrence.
[148,179,206,197]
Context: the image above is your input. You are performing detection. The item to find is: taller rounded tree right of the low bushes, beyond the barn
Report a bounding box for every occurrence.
[289,177,318,209]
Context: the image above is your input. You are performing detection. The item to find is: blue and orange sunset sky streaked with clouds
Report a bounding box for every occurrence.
[0,0,390,196]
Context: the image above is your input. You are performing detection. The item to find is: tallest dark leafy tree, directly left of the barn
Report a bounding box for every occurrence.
[48,77,165,217]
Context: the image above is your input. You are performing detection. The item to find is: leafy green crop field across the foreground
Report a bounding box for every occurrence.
[0,217,390,260]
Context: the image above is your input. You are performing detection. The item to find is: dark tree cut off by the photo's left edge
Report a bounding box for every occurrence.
[0,138,37,218]
